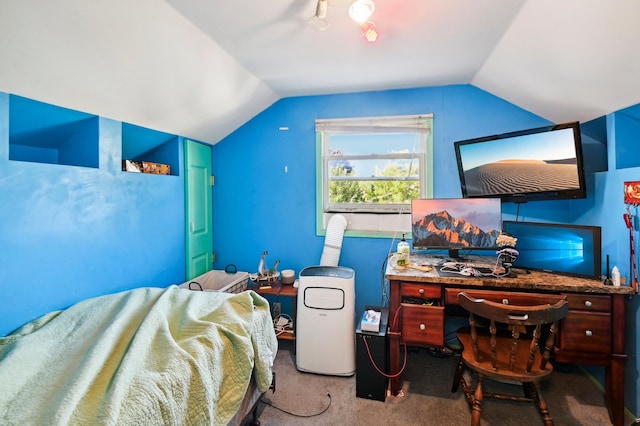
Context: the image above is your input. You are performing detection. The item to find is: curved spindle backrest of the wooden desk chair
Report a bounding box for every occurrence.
[458,292,569,372]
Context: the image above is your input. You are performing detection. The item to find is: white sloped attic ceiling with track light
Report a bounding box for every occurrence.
[0,0,640,143]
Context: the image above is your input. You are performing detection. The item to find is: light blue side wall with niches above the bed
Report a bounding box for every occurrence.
[0,93,185,335]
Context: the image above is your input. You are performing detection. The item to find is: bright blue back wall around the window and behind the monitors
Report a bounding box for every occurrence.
[213,85,640,412]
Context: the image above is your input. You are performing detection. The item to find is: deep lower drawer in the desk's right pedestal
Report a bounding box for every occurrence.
[557,310,611,354]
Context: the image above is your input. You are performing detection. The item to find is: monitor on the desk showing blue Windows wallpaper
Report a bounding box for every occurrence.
[502,220,602,279]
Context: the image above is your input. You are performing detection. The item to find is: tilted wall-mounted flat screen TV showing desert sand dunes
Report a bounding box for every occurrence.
[454,122,587,202]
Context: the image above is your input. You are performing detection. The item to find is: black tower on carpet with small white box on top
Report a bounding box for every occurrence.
[356,306,389,401]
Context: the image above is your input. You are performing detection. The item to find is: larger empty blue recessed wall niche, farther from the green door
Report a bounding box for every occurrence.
[9,95,100,168]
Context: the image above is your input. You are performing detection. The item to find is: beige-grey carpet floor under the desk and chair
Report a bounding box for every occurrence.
[258,341,611,426]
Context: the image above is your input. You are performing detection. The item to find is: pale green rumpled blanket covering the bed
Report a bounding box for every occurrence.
[0,286,278,426]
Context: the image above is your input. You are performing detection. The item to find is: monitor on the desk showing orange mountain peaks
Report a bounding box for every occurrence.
[411,198,502,258]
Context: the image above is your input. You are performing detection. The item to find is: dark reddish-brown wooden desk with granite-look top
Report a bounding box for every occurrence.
[386,254,634,426]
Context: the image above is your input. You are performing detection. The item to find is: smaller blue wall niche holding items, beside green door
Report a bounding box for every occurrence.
[122,123,179,176]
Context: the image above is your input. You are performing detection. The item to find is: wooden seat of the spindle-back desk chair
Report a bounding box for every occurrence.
[458,328,553,383]
